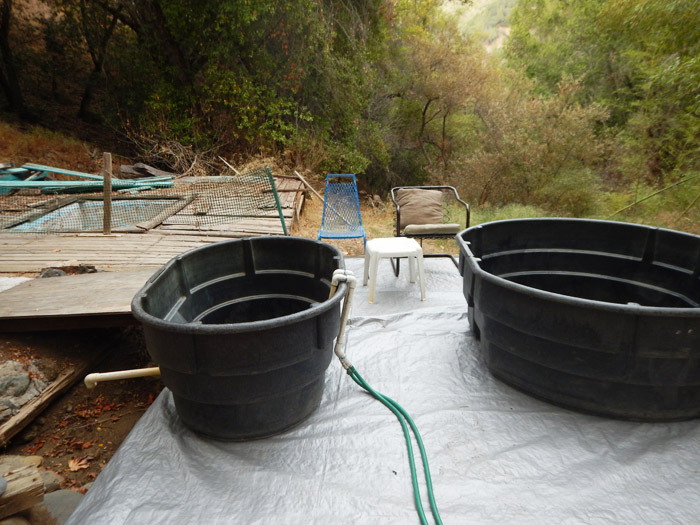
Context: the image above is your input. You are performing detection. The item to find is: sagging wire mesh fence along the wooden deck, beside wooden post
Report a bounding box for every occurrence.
[0,168,287,234]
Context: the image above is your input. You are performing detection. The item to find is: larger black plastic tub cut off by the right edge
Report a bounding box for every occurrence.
[457,219,700,421]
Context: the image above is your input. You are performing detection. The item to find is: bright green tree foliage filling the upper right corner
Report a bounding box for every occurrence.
[508,0,700,189]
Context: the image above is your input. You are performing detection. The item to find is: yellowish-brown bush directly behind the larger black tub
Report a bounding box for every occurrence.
[456,73,607,215]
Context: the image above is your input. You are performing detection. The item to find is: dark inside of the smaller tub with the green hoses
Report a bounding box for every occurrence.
[143,239,338,325]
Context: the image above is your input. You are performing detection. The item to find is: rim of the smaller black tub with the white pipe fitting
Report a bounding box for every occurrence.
[131,235,347,335]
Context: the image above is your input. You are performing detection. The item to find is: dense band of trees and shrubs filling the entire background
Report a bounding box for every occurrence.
[0,0,700,225]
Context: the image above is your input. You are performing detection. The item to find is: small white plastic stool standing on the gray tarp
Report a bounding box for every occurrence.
[362,237,425,303]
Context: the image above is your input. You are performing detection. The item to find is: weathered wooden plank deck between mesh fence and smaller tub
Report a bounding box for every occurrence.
[0,177,304,274]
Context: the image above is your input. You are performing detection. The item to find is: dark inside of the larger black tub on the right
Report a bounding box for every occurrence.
[465,220,700,308]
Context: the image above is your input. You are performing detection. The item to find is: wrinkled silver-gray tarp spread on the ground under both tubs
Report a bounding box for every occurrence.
[68,259,700,525]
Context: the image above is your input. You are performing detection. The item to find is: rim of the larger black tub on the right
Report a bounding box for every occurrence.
[455,217,700,318]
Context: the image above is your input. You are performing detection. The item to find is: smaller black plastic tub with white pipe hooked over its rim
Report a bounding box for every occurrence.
[131,237,345,440]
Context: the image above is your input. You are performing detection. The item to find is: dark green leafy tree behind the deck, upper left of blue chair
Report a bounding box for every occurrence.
[78,0,392,171]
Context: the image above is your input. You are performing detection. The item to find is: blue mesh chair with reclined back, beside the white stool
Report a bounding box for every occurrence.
[318,175,367,245]
